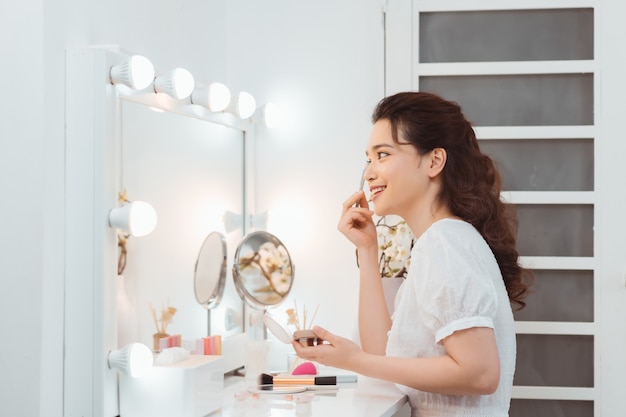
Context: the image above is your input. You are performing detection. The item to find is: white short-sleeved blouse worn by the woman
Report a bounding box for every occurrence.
[387,219,516,417]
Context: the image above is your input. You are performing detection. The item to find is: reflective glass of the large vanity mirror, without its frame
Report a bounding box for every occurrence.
[118,97,245,368]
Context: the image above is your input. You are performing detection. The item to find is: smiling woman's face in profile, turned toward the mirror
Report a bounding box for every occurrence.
[364,119,429,219]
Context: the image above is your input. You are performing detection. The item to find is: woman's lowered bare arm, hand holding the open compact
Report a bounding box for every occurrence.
[294,327,500,395]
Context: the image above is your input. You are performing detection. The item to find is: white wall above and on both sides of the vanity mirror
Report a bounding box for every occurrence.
[0,0,383,417]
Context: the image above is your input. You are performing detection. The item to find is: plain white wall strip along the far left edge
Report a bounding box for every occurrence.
[0,1,47,416]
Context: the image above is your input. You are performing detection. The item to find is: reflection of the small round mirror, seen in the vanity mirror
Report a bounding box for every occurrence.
[193,232,226,309]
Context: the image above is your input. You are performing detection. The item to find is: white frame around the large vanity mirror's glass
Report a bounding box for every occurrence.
[63,45,255,415]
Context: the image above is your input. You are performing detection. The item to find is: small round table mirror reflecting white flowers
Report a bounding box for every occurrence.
[233,231,294,309]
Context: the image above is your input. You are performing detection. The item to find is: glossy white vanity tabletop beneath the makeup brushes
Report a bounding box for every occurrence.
[209,373,407,417]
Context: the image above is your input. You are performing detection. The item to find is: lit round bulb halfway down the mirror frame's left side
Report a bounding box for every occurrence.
[109,201,158,237]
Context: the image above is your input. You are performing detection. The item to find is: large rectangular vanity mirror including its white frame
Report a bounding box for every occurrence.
[62,46,255,416]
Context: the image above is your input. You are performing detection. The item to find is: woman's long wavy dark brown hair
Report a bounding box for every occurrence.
[372,92,533,309]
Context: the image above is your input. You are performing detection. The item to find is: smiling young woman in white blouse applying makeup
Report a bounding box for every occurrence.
[294,92,528,417]
